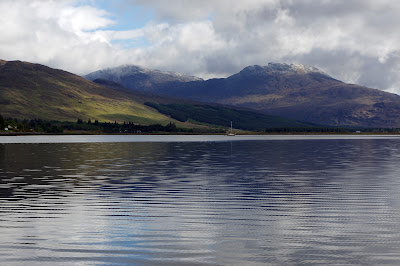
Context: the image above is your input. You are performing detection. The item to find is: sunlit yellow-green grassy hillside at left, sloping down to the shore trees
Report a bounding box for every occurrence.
[0,61,178,124]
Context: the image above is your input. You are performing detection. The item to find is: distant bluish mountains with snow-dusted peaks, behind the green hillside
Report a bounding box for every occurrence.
[85,63,400,127]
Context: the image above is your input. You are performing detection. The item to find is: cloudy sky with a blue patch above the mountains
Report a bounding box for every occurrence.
[0,0,400,94]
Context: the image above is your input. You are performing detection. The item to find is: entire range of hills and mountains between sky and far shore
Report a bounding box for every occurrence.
[0,60,400,130]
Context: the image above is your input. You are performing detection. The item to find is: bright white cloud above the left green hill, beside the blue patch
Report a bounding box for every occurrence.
[0,1,113,73]
